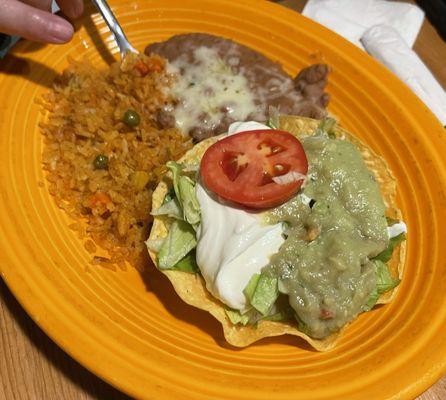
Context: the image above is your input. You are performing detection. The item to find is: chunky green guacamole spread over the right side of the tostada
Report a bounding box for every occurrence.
[263,135,389,338]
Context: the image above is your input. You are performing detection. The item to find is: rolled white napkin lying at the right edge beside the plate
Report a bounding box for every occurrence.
[361,25,446,125]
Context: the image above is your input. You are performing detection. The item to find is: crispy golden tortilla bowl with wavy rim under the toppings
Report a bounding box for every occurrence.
[149,116,406,351]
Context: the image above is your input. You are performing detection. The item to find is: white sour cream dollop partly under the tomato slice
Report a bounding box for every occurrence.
[196,121,285,311]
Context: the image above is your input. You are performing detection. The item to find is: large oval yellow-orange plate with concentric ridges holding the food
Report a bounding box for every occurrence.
[0,0,446,400]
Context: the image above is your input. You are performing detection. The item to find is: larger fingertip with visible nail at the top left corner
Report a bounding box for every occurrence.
[0,0,73,43]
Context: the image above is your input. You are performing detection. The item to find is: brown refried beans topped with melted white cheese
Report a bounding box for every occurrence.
[145,33,329,142]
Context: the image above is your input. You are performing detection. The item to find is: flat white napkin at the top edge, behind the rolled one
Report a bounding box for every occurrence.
[302,0,424,49]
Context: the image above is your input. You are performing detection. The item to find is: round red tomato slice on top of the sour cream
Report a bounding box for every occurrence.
[200,129,308,209]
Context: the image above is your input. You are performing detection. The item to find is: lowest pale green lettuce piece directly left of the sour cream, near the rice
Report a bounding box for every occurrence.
[158,220,197,269]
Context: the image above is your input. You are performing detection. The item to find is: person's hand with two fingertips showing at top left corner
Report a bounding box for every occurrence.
[0,0,84,43]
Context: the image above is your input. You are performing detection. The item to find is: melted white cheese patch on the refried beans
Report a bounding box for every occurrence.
[169,46,256,133]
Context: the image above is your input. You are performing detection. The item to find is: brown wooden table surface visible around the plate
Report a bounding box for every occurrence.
[0,0,446,400]
